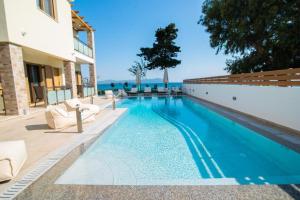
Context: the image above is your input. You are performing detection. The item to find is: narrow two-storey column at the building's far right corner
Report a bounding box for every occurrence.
[87,31,97,94]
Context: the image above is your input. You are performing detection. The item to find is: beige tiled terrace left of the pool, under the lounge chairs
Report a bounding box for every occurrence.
[0,97,121,193]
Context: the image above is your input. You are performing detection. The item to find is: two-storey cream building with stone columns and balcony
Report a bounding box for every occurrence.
[0,0,97,115]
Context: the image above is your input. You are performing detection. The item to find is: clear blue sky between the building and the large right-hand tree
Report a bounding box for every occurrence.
[74,0,227,81]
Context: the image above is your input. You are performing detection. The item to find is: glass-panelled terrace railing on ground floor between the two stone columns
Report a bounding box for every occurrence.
[46,86,72,105]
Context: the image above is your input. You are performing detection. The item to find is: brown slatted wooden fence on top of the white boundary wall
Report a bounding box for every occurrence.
[183,68,300,86]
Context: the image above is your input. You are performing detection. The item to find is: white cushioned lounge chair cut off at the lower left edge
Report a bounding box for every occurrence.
[0,140,27,182]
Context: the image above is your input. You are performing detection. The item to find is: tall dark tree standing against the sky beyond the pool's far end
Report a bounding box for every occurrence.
[138,23,181,86]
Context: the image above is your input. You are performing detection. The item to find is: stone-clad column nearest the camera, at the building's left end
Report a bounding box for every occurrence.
[0,43,29,115]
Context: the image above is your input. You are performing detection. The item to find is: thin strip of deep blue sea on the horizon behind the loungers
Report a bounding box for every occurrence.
[98,82,182,90]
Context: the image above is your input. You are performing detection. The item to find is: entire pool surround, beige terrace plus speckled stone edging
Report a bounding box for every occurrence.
[0,95,300,200]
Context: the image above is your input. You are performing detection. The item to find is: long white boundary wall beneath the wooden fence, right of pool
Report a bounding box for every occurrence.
[183,83,300,131]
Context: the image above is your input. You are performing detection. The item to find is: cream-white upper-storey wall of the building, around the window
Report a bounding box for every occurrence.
[0,0,75,61]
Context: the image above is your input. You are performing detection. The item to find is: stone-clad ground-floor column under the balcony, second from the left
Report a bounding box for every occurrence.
[64,61,77,98]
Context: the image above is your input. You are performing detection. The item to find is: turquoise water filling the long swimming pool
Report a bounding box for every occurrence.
[56,97,300,185]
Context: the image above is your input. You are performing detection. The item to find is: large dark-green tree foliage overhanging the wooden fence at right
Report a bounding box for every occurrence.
[199,0,300,74]
